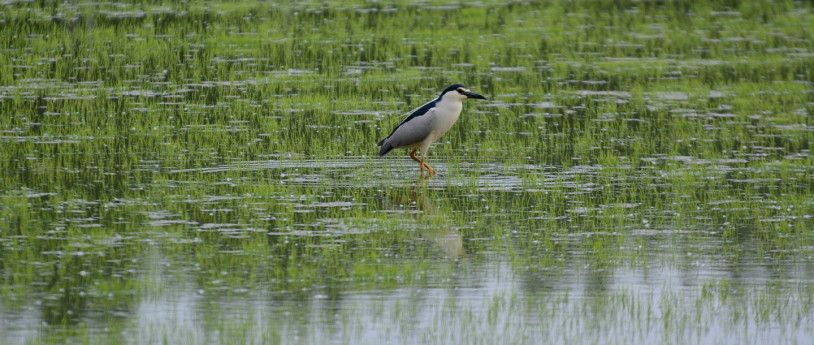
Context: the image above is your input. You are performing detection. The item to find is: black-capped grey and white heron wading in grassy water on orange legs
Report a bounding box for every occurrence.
[376,84,486,176]
